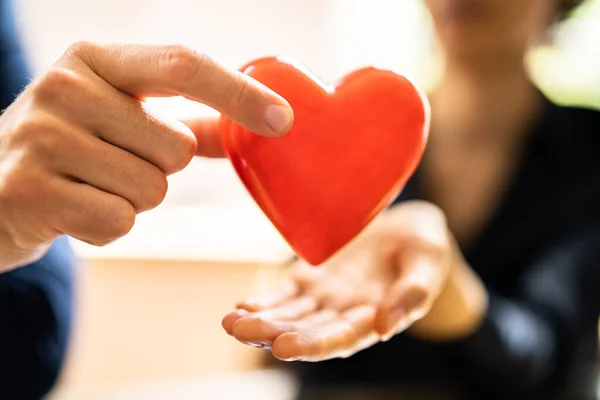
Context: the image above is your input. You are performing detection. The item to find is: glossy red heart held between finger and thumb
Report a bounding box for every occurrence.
[220,57,430,265]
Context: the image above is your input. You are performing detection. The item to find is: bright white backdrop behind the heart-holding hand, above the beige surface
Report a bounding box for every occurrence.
[11,0,429,261]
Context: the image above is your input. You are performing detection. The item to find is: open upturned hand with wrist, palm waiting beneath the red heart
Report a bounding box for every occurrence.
[223,202,486,361]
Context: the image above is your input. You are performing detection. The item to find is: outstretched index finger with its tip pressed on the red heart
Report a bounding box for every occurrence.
[66,43,294,136]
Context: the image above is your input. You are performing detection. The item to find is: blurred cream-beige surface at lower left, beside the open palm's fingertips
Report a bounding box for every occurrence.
[50,259,290,400]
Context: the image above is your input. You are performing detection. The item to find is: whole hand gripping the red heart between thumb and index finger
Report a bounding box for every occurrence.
[0,43,293,272]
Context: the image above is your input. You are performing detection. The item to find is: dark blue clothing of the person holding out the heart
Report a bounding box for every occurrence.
[0,0,75,399]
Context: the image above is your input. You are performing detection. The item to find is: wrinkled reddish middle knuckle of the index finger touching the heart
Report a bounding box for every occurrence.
[159,45,208,85]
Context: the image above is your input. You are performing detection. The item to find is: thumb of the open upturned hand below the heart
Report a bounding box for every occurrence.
[375,252,446,341]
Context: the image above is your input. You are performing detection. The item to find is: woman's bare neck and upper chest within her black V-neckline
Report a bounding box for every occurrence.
[421,52,541,245]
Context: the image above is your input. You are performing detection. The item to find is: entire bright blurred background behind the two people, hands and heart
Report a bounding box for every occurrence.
[8,0,600,399]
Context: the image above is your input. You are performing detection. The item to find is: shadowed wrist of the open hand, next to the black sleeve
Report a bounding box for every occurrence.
[409,257,488,341]
